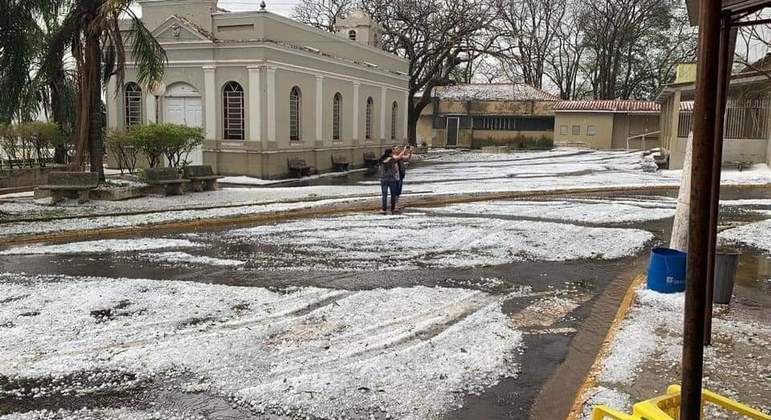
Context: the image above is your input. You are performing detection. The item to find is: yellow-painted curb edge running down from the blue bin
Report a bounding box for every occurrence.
[566,273,647,420]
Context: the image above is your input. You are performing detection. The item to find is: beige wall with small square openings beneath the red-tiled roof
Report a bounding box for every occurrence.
[554,111,613,150]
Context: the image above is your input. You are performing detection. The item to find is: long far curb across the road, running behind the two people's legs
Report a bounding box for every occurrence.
[0,183,771,244]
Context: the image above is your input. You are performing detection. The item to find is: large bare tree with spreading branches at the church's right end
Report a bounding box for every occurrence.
[362,0,499,143]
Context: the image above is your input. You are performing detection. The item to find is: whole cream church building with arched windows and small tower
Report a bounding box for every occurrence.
[106,0,416,178]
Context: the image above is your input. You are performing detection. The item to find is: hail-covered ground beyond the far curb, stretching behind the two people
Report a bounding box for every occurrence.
[0,148,771,237]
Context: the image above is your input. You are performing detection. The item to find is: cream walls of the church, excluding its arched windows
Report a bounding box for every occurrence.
[107,5,409,178]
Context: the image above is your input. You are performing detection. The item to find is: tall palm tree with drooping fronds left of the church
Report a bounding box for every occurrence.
[0,0,166,179]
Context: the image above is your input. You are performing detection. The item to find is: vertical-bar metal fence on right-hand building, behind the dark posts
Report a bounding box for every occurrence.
[677,99,771,139]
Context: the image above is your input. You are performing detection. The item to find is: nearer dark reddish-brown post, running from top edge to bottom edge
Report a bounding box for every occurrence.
[680,0,721,420]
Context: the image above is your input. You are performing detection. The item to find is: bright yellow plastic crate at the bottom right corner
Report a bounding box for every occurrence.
[592,385,771,420]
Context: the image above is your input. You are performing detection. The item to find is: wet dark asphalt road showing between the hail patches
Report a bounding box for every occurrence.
[0,190,771,419]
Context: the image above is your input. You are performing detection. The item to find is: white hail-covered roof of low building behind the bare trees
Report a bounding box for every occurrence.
[434,83,559,101]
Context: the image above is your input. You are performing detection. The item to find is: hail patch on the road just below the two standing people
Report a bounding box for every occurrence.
[225,213,653,271]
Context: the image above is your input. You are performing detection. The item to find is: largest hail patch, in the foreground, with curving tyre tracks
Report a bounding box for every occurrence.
[0,274,522,419]
